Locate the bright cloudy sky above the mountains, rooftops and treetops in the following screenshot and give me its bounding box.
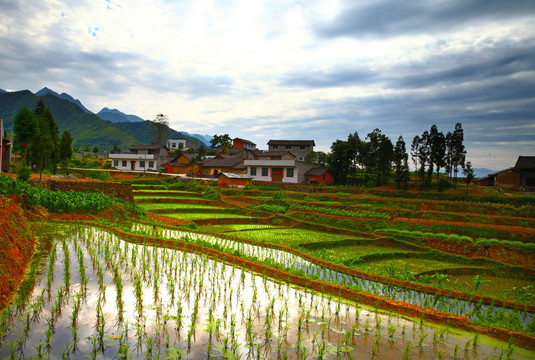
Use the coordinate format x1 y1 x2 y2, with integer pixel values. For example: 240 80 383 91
0 0 535 170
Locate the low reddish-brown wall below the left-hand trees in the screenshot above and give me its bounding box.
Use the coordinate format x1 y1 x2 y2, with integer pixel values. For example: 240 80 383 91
35 180 134 202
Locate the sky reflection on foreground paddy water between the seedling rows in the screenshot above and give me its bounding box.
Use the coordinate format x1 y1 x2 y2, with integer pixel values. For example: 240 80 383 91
0 225 528 359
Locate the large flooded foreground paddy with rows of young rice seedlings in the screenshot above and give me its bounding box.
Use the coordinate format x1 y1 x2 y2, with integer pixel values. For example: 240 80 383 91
0 224 533 359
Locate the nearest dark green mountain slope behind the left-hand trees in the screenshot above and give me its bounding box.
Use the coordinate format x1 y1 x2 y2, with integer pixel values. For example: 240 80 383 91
0 90 142 151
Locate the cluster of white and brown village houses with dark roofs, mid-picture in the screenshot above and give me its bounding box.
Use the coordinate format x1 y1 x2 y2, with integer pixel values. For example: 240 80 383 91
110 138 334 186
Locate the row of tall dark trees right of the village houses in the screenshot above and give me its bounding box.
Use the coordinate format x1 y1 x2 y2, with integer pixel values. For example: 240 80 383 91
324 123 466 189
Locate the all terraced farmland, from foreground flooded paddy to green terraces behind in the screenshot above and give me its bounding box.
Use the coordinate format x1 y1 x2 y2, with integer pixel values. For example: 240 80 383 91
0 176 535 359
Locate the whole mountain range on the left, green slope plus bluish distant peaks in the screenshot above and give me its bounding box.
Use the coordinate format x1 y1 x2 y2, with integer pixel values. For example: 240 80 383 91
0 87 210 151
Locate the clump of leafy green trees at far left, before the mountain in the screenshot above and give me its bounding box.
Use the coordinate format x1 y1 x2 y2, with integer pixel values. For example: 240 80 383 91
13 100 72 179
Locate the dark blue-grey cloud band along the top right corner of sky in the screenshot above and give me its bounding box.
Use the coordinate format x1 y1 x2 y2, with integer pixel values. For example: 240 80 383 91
315 0 535 38
